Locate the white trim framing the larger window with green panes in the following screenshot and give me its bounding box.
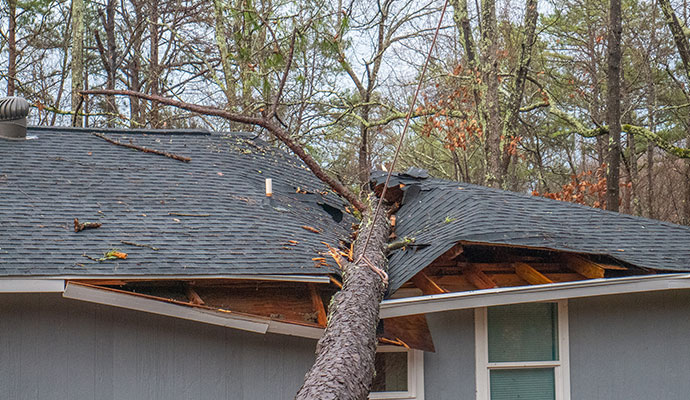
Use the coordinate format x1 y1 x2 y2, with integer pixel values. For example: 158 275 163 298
474 300 570 400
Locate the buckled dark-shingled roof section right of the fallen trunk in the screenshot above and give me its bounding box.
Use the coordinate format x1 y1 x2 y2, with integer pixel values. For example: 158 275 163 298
372 170 690 293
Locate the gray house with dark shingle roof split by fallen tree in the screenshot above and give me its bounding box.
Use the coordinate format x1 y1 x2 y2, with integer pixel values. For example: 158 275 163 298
0 115 690 400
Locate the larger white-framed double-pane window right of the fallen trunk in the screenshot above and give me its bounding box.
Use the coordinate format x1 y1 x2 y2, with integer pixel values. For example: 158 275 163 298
475 301 570 400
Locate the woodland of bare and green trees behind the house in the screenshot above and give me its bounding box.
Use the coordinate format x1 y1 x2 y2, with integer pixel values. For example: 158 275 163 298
0 0 690 225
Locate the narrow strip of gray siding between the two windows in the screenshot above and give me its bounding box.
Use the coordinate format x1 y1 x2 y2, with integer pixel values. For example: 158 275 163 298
424 310 475 400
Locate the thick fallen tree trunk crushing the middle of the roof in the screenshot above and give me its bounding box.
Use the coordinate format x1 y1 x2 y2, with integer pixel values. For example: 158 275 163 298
295 206 390 400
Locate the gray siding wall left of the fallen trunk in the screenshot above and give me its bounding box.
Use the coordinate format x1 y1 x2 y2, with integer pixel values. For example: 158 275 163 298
0 294 316 400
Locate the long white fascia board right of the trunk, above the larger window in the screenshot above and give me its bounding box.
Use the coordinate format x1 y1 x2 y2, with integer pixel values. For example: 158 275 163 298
380 273 690 318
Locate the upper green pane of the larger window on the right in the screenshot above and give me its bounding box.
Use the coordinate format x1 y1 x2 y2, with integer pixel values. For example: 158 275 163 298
487 303 558 362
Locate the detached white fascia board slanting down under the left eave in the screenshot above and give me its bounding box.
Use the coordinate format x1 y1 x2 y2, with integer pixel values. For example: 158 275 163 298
62 283 269 334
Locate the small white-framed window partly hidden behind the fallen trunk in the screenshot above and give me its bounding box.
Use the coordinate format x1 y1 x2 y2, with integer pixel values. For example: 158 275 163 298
369 346 424 400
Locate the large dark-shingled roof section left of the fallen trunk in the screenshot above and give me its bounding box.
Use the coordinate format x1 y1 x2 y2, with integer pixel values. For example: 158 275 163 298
0 127 354 277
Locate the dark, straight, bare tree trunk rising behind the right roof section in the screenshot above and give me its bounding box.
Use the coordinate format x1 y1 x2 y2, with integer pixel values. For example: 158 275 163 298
606 0 623 211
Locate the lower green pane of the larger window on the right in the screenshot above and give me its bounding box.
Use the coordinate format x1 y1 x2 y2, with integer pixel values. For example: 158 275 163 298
489 368 556 400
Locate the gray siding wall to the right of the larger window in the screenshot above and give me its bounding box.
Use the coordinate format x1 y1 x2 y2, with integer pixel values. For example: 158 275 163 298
569 290 690 400
